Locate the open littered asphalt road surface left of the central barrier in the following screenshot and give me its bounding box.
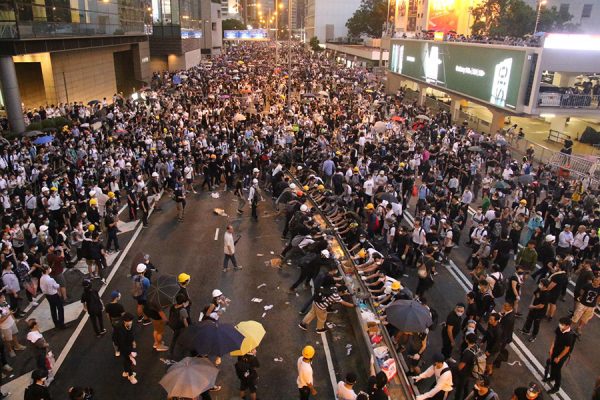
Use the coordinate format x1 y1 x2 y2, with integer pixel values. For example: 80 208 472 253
35 188 368 400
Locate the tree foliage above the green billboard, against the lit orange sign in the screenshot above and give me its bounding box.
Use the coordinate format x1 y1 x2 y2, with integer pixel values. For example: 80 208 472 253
471 0 574 37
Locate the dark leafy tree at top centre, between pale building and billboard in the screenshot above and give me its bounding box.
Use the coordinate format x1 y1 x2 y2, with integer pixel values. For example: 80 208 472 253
346 0 387 37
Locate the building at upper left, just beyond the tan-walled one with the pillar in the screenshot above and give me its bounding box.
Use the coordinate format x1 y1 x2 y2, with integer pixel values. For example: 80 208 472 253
150 0 223 71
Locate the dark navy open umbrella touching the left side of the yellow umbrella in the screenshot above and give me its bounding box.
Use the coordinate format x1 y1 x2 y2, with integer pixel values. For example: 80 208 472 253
178 320 244 357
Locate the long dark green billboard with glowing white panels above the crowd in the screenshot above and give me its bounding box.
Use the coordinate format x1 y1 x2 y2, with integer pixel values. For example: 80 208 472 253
389 40 526 110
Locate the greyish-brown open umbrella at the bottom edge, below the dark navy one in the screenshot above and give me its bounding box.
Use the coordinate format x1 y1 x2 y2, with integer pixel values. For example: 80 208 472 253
159 357 219 399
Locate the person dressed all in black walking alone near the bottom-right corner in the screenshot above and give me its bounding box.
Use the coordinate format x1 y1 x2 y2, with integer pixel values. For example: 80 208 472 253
542 317 576 394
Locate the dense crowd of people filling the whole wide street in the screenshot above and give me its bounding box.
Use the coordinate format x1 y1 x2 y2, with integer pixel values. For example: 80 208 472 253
0 38 600 400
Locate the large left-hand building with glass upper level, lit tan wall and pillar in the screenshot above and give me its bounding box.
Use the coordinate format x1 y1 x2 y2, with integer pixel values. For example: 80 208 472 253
0 0 152 131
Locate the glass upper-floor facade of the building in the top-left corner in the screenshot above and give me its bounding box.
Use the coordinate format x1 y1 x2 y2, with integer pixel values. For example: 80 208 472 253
0 0 152 39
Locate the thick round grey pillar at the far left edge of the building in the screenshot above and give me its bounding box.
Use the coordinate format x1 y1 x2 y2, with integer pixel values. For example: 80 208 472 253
0 56 25 133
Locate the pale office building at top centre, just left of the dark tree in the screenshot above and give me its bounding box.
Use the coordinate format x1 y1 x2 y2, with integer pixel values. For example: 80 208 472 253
304 0 361 43
